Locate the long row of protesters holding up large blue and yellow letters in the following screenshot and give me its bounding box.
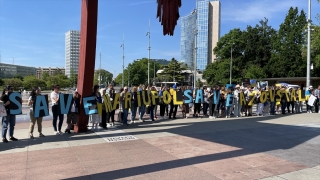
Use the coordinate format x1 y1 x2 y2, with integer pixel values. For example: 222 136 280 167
1 84 320 143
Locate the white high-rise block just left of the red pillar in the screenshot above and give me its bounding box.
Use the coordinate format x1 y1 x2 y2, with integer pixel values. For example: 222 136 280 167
65 30 80 77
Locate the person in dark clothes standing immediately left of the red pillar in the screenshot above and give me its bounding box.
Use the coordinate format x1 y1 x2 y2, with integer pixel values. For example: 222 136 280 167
65 91 80 134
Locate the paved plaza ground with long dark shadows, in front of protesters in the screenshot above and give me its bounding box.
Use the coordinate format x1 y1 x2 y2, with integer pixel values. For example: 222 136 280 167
0 113 320 180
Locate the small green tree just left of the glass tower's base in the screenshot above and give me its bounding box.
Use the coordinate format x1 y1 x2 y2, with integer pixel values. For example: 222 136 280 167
159 58 186 82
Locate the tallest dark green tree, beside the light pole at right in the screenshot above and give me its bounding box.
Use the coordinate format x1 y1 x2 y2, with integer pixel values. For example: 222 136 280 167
268 7 307 77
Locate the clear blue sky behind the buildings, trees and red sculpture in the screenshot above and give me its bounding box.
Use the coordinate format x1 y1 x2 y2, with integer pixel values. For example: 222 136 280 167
0 0 320 75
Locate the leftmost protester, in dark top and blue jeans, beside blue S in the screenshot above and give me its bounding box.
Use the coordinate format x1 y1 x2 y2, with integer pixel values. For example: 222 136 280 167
1 86 18 143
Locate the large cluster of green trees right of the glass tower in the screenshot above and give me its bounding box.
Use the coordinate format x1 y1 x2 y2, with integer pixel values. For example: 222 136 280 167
203 8 310 84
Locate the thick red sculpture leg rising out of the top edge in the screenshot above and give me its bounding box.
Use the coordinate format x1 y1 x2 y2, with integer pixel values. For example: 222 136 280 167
74 0 98 132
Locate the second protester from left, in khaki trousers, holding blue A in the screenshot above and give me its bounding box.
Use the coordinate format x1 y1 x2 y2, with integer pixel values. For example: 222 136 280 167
28 87 44 139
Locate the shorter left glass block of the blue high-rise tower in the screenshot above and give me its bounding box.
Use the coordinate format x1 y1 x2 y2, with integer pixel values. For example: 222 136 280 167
180 10 197 69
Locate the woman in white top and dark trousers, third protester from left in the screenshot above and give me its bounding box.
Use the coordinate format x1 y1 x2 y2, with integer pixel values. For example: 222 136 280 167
50 84 64 135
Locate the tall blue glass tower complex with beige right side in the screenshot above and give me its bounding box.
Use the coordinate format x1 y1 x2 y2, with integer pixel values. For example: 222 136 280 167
181 0 221 70
